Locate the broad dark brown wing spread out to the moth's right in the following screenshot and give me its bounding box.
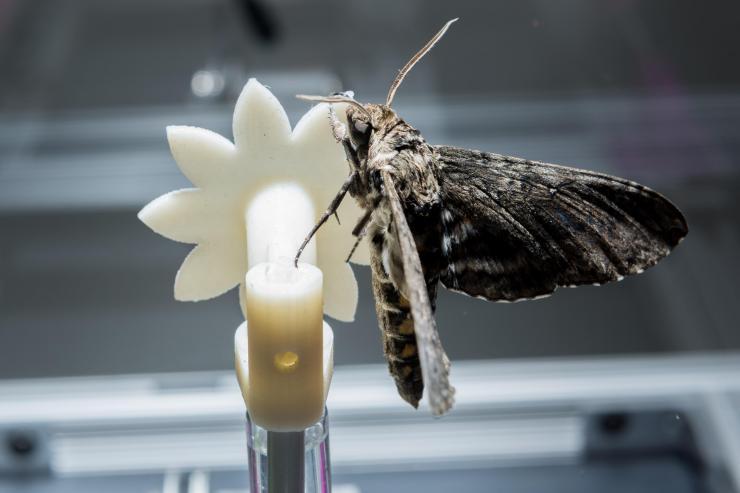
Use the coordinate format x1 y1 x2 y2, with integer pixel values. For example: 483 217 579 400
435 146 688 301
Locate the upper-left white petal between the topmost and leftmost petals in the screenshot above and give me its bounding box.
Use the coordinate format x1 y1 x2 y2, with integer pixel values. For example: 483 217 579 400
167 126 236 188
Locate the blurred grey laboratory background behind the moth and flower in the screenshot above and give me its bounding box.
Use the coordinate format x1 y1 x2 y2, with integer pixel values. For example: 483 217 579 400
0 0 740 493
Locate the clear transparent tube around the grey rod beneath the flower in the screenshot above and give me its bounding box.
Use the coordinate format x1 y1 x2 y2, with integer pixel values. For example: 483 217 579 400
247 410 331 493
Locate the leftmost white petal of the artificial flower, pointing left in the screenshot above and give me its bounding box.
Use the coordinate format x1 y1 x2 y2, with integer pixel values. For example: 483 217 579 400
138 188 213 243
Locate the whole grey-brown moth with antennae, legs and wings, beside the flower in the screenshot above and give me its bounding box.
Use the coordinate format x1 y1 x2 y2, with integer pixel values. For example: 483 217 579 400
296 19 688 415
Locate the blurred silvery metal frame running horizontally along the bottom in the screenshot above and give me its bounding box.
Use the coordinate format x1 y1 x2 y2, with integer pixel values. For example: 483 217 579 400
0 353 740 490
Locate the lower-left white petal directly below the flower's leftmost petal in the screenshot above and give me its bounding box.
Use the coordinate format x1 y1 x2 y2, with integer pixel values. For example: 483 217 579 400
175 241 247 301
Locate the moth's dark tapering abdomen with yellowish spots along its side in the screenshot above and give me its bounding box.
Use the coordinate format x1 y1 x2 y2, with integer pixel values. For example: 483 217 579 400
370 248 424 407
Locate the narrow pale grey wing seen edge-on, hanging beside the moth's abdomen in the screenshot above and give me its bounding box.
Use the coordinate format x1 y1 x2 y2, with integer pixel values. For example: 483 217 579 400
381 171 455 416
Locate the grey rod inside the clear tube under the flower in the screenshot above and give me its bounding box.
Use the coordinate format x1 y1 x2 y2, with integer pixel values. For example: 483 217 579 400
267 431 306 493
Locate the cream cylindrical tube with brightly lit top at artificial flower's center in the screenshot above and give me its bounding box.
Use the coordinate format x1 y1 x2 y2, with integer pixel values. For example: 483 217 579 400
245 182 325 431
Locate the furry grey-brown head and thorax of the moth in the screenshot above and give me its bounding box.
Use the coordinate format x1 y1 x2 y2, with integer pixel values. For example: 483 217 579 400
347 104 439 208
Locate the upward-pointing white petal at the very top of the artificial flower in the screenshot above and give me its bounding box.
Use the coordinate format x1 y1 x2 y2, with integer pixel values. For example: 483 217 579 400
233 79 290 153
